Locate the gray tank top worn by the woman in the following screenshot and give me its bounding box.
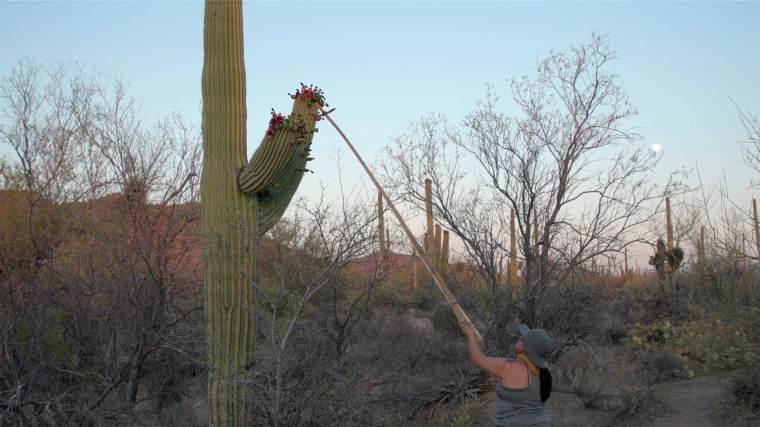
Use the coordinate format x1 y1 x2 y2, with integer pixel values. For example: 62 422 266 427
494 359 552 427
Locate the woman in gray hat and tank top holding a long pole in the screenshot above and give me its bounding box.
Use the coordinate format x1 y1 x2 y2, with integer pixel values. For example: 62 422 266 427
459 323 552 427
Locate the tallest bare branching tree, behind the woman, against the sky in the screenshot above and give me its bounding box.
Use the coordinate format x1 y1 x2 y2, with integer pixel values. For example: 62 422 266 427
382 33 678 334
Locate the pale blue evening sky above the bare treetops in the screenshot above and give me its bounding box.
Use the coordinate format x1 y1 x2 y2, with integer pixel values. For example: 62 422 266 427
0 0 760 264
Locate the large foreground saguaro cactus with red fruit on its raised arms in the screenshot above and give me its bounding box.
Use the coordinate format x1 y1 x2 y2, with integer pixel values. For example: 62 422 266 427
201 0 323 427
